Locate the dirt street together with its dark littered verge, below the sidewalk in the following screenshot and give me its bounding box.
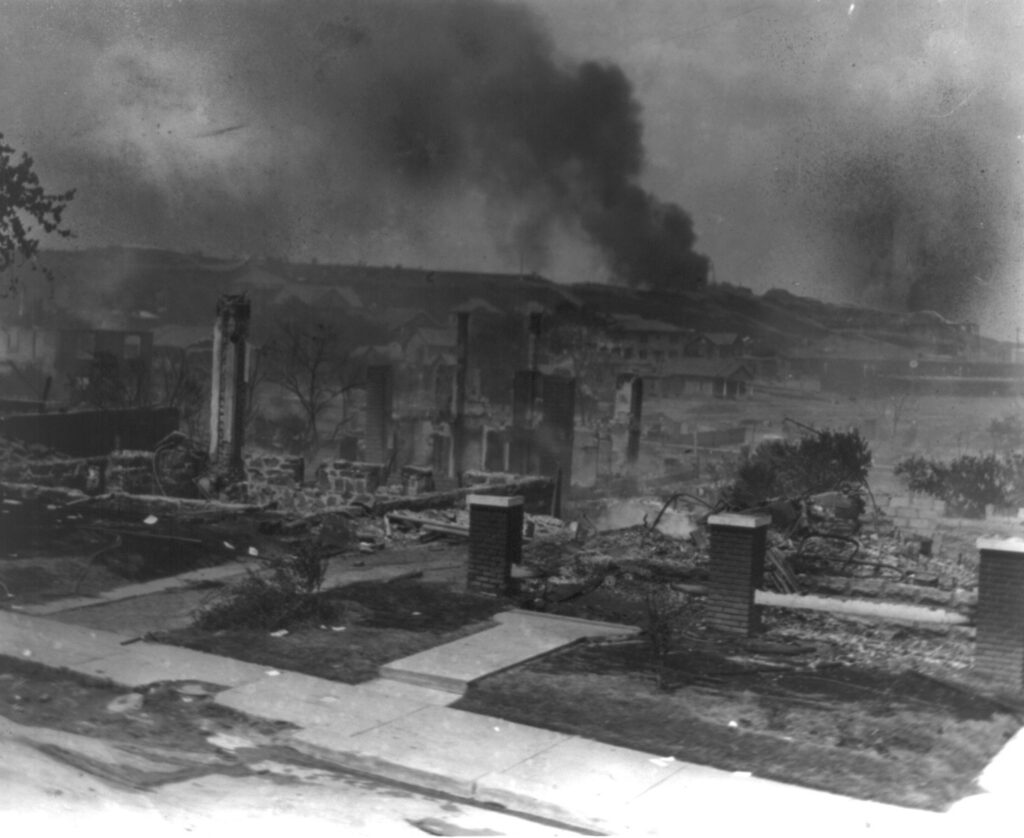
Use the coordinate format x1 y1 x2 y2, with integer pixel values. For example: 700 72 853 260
0 658 566 838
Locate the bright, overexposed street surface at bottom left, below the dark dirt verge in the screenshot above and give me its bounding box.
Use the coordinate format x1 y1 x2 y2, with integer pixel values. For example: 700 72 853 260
0 732 570 838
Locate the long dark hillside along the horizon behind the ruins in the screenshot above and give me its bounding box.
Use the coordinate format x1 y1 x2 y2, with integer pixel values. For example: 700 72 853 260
6 247 991 349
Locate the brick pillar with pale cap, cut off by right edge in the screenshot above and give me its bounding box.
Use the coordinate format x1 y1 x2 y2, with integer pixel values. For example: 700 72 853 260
974 538 1024 689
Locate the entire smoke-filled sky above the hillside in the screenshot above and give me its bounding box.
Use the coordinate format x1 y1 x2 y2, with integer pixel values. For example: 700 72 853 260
0 0 1024 337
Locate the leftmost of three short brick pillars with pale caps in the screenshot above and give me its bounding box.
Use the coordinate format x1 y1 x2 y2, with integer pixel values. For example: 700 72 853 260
466 495 522 596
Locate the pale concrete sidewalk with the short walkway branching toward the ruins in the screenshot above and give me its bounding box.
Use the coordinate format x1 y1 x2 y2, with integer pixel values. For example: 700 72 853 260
0 612 1007 836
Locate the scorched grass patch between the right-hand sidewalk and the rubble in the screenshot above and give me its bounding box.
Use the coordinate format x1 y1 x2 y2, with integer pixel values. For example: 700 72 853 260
455 643 1020 809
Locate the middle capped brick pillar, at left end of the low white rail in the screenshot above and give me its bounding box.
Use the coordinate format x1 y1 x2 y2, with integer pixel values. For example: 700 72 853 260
708 514 771 635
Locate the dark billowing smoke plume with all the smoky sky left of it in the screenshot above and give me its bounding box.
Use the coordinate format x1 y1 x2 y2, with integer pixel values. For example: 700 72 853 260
0 0 708 287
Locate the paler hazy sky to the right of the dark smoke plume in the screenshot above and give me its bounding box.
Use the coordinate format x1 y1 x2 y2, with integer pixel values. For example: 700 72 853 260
548 0 1024 329
